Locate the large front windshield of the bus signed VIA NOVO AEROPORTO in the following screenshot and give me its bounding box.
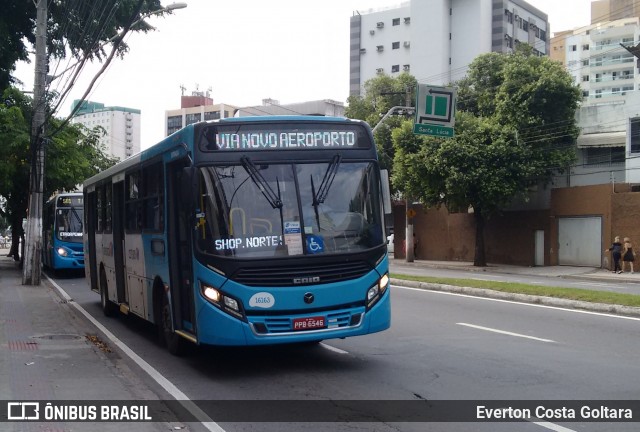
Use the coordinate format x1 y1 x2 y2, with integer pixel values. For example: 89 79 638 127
196 160 383 258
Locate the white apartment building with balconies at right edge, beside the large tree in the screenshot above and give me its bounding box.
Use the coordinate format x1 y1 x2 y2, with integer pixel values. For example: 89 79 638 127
551 17 640 186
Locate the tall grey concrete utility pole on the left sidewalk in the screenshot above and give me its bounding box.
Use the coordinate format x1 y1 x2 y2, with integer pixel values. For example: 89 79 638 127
22 0 47 285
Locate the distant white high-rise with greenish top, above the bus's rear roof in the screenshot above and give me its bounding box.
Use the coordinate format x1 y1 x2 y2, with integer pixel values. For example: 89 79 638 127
72 100 140 160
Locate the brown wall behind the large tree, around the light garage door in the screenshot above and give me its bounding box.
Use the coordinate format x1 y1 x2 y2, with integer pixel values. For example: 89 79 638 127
394 184 640 266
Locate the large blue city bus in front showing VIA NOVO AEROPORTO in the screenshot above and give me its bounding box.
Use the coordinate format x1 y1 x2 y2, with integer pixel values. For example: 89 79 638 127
84 116 391 354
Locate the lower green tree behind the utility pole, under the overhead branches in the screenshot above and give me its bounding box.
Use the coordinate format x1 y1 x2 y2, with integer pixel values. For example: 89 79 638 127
0 88 116 260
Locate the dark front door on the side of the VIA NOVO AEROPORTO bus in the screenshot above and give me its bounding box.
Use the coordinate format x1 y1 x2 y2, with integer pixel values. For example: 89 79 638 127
167 161 196 334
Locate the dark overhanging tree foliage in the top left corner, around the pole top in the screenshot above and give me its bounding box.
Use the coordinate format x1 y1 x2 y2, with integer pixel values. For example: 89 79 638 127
0 0 162 92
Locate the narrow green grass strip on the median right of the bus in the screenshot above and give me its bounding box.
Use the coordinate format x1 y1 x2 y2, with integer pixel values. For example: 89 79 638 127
391 273 640 307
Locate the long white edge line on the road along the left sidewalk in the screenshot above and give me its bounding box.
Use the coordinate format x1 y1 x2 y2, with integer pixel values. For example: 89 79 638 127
44 274 225 432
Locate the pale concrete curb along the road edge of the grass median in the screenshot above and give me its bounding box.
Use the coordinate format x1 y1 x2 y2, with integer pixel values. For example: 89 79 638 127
391 278 640 318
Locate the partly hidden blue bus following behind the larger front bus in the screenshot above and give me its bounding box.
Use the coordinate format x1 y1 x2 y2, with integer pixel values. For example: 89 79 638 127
42 192 84 271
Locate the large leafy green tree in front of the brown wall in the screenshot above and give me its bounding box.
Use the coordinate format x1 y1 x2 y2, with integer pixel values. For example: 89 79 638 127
392 45 581 266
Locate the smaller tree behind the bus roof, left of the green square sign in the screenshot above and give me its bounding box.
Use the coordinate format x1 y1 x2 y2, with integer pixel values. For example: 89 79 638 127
345 72 417 176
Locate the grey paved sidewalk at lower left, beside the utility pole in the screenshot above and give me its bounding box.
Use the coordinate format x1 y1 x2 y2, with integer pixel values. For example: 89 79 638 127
0 253 189 432
